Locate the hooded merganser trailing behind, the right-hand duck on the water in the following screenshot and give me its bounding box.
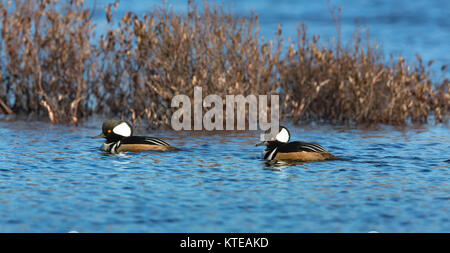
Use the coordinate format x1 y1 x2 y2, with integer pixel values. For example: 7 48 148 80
256 126 340 162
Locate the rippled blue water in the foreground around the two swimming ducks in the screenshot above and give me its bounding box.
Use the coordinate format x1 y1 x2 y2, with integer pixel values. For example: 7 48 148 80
0 120 450 233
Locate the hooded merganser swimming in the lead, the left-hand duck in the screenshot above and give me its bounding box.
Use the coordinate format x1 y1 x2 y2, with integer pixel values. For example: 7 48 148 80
93 119 178 154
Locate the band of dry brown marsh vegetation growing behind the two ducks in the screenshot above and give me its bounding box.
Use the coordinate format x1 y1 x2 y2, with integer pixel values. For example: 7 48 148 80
0 0 450 127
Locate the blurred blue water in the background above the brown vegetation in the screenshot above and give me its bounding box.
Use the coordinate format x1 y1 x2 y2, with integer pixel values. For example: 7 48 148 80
89 0 450 78
